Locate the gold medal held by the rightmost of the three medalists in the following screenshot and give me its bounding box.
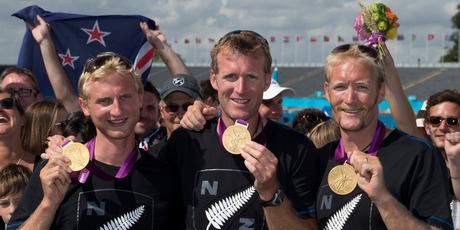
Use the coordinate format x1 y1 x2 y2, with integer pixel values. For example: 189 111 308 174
327 162 358 195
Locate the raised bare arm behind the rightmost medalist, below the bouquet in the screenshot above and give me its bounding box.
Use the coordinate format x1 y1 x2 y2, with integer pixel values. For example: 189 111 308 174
379 38 425 139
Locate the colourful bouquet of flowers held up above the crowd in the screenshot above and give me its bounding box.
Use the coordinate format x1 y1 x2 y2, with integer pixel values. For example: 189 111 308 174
353 3 399 53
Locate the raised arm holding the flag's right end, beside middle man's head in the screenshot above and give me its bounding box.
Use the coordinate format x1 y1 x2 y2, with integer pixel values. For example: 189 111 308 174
140 22 193 76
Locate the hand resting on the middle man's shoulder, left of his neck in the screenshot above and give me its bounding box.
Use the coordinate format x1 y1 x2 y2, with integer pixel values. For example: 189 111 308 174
180 101 218 131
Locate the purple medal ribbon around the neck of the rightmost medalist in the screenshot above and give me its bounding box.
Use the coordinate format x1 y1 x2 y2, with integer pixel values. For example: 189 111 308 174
334 121 386 164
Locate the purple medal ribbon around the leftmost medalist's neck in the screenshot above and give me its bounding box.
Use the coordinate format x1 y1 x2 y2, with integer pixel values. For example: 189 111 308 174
62 137 139 184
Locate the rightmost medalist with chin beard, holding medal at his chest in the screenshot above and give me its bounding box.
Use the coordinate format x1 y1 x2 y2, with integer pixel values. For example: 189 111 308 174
317 40 452 229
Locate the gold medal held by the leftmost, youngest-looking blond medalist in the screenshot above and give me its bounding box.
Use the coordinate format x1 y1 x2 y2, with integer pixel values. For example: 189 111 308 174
62 141 89 172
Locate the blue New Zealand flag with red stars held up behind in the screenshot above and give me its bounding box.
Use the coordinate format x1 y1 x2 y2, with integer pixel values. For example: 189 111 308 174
13 5 155 97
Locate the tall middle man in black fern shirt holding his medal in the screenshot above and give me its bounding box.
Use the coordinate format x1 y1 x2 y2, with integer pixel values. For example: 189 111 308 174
162 31 317 229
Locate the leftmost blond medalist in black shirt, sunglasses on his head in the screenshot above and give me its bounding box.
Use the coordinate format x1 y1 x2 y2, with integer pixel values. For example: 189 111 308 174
8 53 183 229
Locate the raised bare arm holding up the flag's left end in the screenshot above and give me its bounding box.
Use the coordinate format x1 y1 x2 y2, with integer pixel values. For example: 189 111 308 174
26 15 81 112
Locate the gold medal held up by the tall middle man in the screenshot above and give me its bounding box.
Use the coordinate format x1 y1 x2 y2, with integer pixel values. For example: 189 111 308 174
222 121 251 154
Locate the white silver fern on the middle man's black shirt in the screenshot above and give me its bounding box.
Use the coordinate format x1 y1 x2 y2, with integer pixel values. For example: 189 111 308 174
205 186 256 230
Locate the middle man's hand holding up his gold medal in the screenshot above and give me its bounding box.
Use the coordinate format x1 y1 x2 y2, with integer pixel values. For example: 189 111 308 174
241 141 280 201
